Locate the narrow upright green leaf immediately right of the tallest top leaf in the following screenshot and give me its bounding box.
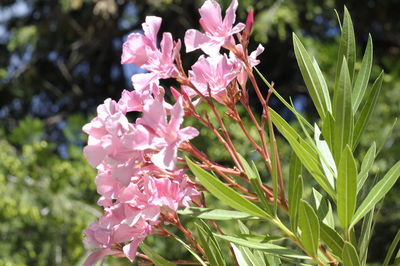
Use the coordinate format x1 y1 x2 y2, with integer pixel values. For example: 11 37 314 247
351 35 373 114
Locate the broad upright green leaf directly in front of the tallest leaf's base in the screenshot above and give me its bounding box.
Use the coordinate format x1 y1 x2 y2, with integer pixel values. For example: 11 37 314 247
333 58 354 163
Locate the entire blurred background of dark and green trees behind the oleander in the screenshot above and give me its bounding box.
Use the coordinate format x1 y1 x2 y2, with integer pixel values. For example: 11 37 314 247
0 0 400 265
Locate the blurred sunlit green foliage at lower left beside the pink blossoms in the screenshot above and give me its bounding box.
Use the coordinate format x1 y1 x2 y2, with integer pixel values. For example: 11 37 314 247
0 118 101 265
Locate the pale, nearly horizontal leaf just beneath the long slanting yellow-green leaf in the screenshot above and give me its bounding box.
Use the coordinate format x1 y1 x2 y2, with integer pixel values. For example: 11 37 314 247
177 207 260 221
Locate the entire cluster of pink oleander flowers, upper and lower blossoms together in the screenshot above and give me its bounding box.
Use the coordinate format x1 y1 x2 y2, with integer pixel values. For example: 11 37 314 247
83 0 263 265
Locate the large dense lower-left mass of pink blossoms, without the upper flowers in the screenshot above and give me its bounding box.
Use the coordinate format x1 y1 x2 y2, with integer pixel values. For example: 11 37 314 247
83 91 198 265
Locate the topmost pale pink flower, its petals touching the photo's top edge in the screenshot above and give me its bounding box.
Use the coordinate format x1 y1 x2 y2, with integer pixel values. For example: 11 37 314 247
185 0 245 55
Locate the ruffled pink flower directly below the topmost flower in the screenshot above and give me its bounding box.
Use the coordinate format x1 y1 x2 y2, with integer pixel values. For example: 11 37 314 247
189 55 239 103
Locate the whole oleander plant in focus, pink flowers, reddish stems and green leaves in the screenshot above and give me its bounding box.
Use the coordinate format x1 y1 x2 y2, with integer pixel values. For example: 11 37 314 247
83 0 400 265
